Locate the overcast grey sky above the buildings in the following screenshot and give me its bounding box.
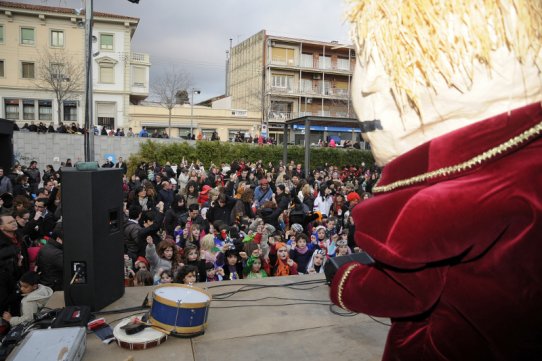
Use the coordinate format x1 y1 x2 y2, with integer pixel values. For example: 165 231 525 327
20 0 351 101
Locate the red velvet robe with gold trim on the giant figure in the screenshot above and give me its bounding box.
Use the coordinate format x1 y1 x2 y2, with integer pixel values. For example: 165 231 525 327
331 103 542 360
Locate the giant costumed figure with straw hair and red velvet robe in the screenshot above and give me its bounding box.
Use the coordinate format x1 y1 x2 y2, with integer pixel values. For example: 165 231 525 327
331 0 542 360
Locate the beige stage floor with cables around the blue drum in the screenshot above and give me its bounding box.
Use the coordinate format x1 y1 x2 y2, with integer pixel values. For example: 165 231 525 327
47 275 389 361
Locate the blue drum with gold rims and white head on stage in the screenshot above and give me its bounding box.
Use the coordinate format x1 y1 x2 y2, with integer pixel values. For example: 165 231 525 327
150 283 215 337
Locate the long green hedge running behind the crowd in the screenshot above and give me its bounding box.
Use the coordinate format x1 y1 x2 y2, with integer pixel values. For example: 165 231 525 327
128 140 374 174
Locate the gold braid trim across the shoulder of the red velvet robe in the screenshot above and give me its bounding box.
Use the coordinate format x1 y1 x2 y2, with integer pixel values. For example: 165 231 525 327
373 122 542 193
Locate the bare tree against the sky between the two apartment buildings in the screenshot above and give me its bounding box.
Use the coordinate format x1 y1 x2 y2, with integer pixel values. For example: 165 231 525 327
151 68 191 138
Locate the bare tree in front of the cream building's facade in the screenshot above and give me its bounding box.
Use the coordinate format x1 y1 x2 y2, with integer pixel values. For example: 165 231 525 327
36 50 85 123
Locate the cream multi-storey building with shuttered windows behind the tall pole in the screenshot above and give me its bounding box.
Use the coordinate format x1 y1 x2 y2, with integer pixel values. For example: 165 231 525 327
0 1 151 128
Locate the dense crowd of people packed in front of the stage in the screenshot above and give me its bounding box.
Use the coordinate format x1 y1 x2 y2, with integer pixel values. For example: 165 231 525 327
0 158 380 328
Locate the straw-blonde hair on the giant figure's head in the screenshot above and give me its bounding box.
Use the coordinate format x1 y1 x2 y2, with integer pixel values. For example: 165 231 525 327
349 0 542 122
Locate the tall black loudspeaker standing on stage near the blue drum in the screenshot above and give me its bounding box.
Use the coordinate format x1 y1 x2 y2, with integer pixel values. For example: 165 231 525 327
61 168 124 311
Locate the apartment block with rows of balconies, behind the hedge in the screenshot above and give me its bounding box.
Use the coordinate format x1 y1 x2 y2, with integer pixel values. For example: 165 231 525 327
228 30 355 141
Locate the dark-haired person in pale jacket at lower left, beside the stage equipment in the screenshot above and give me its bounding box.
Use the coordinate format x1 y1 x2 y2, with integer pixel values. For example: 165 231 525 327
2 271 53 327
